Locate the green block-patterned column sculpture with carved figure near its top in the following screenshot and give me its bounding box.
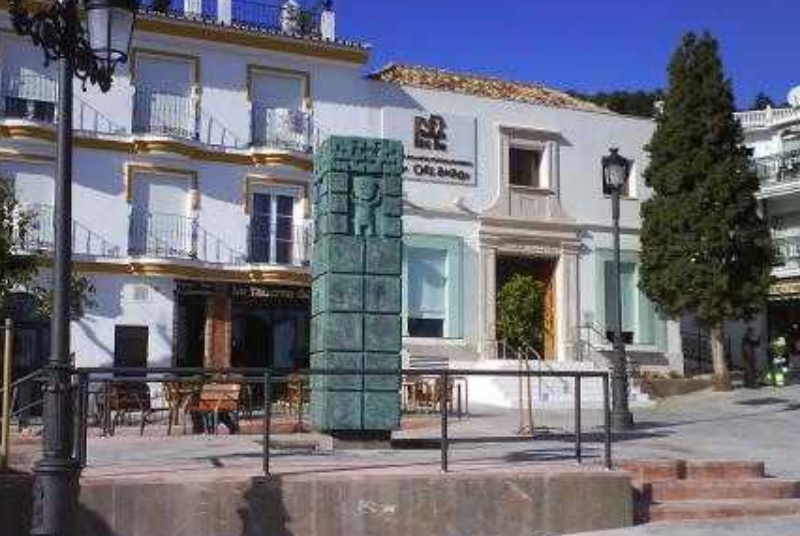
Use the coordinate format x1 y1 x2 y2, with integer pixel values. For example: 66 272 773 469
311 137 403 439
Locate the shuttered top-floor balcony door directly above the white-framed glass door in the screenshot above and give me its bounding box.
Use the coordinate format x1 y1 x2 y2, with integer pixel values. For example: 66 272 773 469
250 70 310 151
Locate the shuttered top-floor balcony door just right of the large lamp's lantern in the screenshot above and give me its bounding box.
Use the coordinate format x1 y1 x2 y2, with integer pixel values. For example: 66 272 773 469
134 54 197 139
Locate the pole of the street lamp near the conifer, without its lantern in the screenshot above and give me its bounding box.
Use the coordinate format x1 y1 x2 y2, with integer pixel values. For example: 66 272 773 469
611 186 634 431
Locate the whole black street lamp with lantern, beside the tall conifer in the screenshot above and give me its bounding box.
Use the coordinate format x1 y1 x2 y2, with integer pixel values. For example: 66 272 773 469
602 149 634 431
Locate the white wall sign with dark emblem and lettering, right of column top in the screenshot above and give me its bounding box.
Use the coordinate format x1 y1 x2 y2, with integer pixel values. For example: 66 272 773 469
382 108 477 185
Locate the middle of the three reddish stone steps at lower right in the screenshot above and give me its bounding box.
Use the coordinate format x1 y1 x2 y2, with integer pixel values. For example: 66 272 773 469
648 478 800 503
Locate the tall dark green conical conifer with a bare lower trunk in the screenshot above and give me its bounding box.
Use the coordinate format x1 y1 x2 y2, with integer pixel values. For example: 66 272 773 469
641 33 772 389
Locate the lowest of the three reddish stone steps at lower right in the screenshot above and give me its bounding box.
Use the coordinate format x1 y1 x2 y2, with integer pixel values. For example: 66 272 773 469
649 499 800 522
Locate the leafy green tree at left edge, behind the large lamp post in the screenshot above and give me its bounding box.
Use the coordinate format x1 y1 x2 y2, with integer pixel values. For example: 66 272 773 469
0 179 95 319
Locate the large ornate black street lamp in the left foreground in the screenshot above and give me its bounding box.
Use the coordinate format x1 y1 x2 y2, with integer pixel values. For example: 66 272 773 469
9 0 138 536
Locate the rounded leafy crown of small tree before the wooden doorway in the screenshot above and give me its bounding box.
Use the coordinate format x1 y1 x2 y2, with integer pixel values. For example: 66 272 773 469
497 274 546 352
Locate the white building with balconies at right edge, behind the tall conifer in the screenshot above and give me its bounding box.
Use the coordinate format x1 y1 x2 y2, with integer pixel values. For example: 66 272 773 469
737 88 800 360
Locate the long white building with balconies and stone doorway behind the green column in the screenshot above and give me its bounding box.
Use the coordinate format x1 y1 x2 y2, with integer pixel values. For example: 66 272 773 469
0 0 682 402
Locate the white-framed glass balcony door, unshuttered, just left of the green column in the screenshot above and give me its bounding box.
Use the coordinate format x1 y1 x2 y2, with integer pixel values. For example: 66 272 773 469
250 192 295 264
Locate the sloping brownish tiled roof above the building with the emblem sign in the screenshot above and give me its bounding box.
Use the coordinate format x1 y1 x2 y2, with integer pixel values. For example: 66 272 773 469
369 63 614 114
